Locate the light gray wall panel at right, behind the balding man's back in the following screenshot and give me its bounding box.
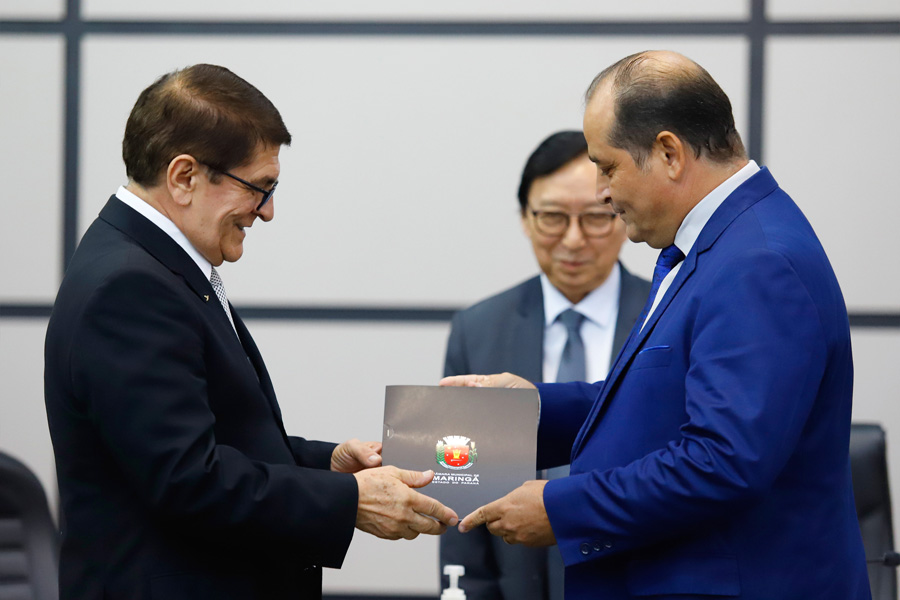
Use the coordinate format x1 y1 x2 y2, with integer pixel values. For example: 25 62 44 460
765 37 900 313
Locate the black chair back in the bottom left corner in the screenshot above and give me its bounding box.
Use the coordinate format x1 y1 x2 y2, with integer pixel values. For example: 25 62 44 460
0 452 59 600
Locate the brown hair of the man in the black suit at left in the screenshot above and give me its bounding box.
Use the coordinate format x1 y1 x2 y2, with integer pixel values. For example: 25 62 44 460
122 64 291 187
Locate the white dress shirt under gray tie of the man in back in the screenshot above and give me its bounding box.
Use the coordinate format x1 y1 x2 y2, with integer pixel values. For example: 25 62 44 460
541 263 622 383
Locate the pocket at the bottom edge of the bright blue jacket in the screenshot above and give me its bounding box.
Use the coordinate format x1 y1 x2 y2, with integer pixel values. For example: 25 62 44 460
625 555 741 597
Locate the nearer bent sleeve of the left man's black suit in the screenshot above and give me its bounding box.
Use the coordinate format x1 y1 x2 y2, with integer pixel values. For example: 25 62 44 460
69 271 357 566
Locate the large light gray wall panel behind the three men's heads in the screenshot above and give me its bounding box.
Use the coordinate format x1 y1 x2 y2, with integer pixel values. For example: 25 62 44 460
79 36 747 306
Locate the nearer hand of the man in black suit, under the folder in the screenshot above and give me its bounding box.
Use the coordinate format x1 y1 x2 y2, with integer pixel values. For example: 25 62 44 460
353 467 459 540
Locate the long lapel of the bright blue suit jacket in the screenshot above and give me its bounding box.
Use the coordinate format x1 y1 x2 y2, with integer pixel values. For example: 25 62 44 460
572 167 778 459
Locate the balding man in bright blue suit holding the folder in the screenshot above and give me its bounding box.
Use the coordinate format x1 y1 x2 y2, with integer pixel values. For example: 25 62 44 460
444 52 870 600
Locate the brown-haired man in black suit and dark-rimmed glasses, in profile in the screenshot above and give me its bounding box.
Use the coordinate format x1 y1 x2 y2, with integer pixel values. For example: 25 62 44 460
45 65 456 600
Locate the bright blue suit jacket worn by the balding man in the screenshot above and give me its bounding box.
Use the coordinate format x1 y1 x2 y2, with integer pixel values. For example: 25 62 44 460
538 169 870 600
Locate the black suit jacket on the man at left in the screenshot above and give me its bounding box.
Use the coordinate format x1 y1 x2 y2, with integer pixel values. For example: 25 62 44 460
44 197 358 600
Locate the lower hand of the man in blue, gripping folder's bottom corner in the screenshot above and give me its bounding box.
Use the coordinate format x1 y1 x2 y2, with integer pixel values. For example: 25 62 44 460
459 481 556 546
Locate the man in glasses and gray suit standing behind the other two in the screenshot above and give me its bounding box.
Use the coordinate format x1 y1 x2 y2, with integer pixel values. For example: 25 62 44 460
440 131 650 600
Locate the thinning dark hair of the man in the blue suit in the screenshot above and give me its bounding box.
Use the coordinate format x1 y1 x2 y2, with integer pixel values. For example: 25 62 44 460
585 52 746 167
